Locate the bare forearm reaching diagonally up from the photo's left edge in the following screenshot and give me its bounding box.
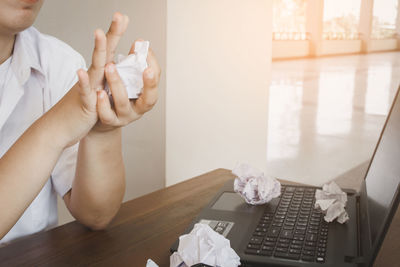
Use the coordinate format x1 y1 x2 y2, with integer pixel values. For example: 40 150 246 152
0 84 97 239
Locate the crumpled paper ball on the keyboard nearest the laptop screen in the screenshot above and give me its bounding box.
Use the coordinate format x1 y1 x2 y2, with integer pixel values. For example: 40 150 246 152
315 182 349 223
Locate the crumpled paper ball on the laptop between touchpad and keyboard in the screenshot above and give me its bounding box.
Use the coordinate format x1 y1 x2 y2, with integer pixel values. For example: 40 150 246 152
232 164 281 205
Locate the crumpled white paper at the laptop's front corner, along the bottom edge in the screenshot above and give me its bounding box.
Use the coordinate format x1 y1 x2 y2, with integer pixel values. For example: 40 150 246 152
170 223 240 267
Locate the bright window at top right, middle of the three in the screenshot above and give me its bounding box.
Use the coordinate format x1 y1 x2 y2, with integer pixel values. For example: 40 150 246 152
323 0 362 40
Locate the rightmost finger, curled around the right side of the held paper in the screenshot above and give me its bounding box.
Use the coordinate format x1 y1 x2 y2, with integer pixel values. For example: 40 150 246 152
132 68 158 114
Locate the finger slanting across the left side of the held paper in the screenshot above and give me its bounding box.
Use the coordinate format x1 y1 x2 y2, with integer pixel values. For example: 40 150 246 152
106 63 131 117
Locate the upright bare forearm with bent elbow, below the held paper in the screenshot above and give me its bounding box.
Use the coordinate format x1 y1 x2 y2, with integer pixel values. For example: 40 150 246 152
64 129 125 229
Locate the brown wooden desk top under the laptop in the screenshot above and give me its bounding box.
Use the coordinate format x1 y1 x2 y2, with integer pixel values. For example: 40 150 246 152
0 169 400 267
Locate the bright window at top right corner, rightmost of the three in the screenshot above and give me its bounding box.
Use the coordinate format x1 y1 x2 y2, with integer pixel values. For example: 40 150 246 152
371 0 398 39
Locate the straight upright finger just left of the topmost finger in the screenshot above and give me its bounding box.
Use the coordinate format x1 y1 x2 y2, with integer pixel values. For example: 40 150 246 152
88 29 107 88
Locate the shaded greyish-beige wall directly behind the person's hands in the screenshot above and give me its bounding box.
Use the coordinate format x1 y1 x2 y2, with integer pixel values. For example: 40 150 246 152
35 0 166 226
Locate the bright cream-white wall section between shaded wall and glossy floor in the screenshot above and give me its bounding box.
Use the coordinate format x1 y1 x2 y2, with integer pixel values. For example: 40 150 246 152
166 0 272 185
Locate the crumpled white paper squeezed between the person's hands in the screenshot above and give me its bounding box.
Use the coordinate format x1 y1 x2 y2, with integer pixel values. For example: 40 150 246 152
104 41 150 99
